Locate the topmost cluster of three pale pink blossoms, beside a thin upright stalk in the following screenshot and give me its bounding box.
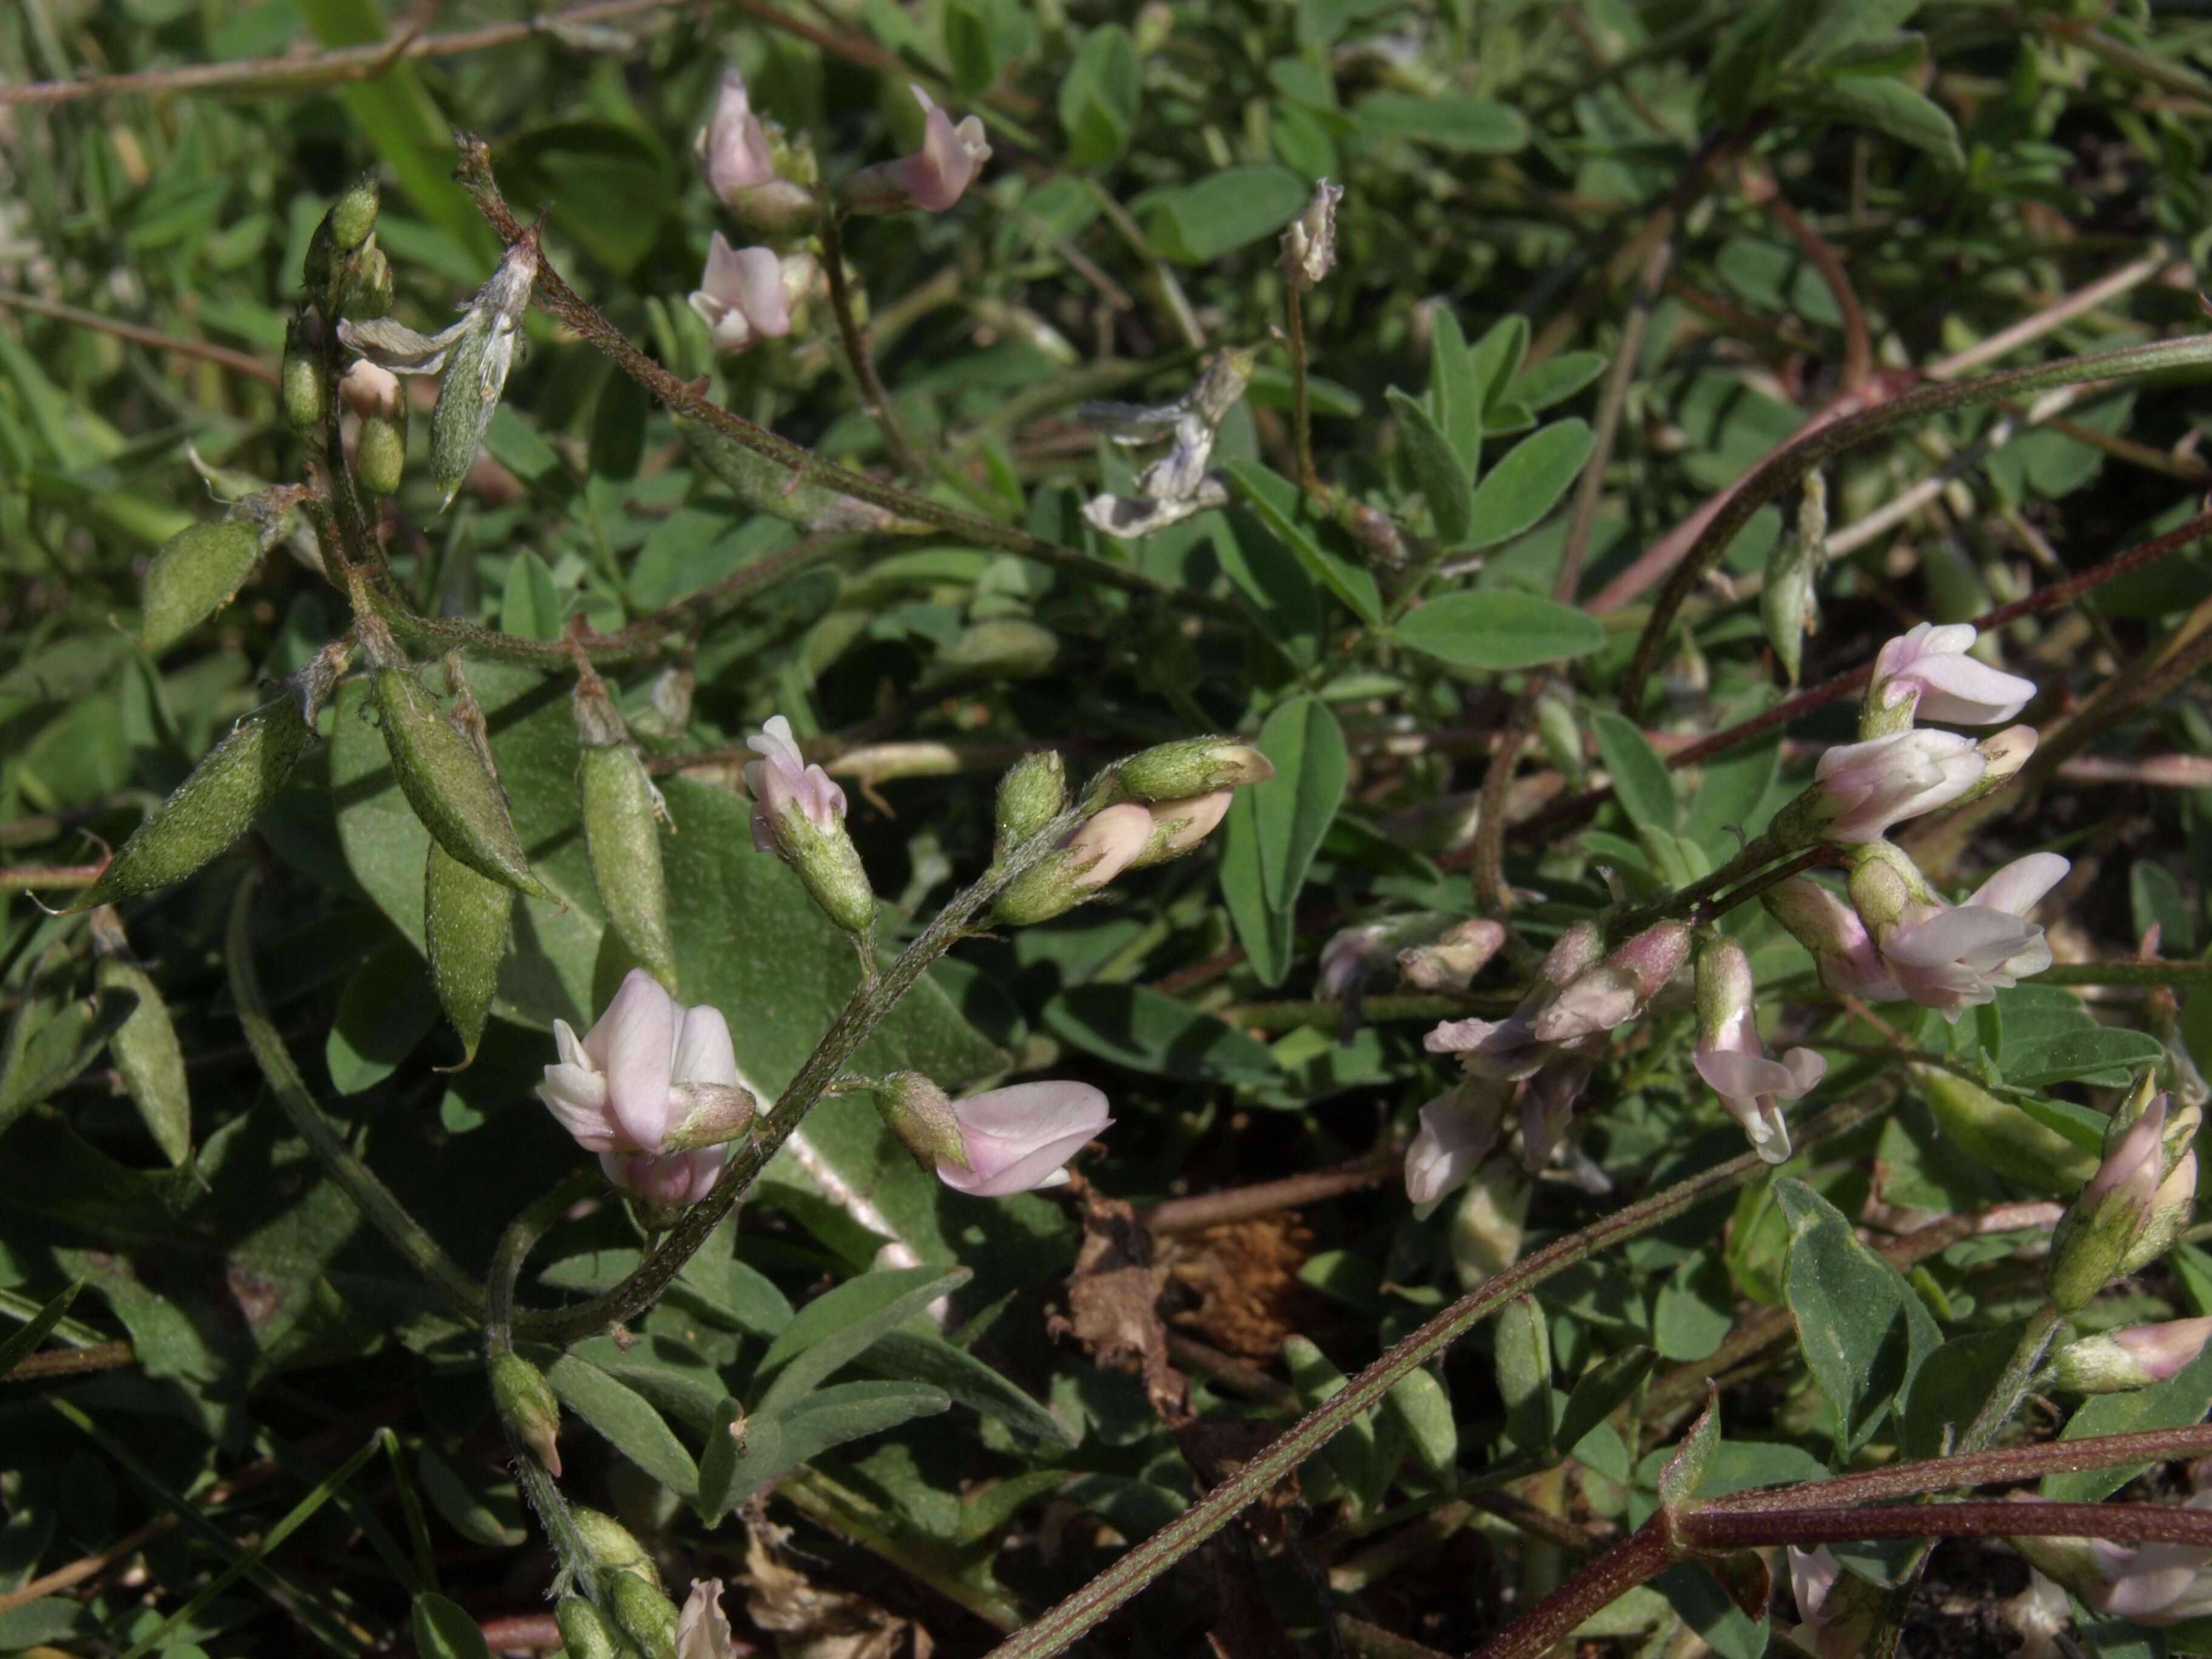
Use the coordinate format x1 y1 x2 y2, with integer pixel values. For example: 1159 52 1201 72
690 69 991 354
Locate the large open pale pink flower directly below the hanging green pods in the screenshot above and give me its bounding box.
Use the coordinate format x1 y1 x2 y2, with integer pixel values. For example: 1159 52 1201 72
537 969 739 1205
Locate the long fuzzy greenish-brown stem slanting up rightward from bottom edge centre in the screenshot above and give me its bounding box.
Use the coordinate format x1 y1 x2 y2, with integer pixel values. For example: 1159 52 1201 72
989 1104 1874 1659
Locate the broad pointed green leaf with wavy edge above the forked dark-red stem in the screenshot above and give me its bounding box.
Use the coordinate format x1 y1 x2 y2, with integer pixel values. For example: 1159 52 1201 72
1774 1181 1942 1460
